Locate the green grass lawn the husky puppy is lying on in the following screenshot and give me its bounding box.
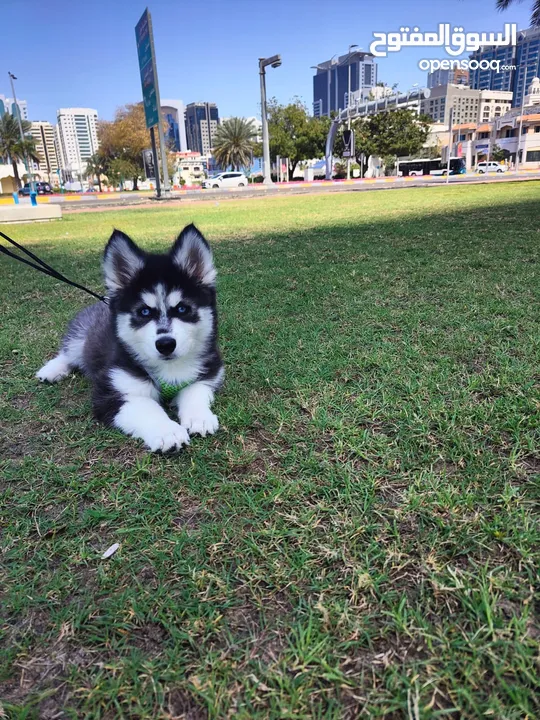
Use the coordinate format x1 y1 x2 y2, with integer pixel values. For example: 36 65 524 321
0 182 540 720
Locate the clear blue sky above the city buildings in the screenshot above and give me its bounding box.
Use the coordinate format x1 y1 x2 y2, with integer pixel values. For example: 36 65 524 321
0 0 532 122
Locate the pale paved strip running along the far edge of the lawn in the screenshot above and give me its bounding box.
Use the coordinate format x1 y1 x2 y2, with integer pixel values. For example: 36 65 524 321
2 170 540 211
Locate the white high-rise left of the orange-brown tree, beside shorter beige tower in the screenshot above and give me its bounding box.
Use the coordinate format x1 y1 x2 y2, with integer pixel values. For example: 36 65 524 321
57 108 99 177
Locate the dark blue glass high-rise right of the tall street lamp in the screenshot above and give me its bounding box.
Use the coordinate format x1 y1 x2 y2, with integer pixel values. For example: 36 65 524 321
313 50 377 117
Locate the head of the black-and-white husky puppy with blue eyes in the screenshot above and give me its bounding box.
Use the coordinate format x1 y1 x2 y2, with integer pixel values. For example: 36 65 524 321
103 225 216 367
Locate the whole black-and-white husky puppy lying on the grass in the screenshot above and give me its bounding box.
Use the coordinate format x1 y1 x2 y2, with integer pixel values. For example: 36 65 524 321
37 225 224 452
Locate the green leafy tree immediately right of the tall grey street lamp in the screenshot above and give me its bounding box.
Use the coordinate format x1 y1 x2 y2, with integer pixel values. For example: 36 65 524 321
255 98 330 177
